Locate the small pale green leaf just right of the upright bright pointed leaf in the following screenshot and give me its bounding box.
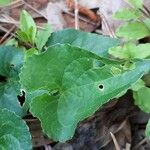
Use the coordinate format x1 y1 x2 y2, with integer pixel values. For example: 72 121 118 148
36 24 52 51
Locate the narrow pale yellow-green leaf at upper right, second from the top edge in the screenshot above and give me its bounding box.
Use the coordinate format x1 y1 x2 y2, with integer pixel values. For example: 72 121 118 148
113 8 142 20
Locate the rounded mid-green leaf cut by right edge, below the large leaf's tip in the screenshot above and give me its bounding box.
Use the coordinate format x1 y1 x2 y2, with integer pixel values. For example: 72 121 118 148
133 87 150 113
